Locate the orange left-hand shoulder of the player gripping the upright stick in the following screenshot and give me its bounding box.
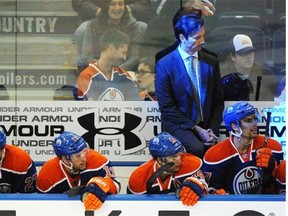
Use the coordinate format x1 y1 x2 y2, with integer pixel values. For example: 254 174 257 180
203 139 237 163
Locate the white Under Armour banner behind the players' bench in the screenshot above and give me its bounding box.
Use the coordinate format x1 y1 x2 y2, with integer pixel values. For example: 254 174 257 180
0 101 286 162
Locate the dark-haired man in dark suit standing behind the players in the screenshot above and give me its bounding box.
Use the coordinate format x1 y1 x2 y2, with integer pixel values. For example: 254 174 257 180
155 10 224 158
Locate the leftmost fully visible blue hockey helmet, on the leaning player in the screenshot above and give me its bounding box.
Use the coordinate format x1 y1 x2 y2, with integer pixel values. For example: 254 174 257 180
52 131 87 157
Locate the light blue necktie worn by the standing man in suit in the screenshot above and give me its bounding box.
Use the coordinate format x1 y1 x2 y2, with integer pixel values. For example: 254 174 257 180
188 56 201 124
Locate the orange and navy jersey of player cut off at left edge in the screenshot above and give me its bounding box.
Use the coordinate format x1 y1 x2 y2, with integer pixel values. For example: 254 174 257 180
0 145 37 193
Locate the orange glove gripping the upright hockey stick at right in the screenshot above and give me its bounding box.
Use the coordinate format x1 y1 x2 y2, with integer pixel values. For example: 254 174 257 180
256 148 277 173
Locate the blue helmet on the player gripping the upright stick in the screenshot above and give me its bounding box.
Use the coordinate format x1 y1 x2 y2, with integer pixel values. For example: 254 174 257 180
223 102 260 131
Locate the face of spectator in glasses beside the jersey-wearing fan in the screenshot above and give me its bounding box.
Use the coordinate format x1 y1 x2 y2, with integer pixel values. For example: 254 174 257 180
136 63 154 90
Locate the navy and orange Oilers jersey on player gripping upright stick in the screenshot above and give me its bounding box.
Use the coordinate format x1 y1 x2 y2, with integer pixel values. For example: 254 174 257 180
202 135 283 194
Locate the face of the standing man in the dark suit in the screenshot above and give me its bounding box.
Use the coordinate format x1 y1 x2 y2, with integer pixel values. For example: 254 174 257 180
180 26 205 55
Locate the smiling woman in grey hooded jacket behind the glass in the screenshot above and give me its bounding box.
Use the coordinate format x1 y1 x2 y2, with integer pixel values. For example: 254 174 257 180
74 0 147 72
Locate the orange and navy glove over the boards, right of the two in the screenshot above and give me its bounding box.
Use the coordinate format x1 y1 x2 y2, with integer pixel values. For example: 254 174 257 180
176 177 208 206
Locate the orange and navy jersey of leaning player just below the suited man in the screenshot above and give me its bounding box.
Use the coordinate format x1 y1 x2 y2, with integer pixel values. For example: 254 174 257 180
127 153 203 194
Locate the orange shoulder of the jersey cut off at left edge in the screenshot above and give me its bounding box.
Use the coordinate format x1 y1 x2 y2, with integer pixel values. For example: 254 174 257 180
5 145 32 172
